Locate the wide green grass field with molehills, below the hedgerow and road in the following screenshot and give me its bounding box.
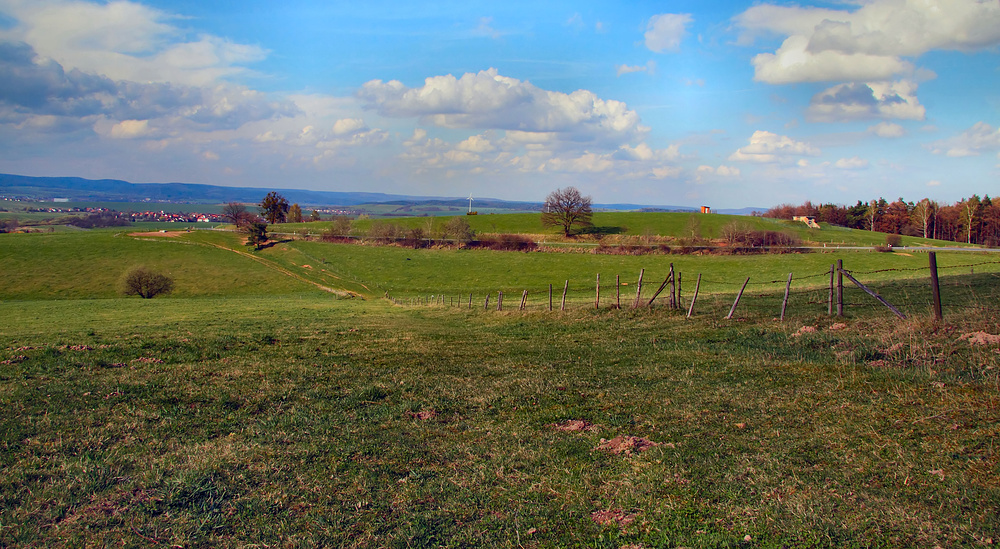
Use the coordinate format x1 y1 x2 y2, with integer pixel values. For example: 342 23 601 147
0 220 1000 548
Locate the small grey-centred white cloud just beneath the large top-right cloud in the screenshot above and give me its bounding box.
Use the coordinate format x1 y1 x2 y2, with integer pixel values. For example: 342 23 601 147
806 80 926 122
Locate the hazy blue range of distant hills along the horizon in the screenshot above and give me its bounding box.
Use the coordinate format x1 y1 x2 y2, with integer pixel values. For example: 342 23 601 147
0 174 766 215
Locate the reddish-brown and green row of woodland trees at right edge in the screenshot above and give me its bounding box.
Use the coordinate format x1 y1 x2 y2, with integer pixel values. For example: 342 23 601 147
761 194 1000 246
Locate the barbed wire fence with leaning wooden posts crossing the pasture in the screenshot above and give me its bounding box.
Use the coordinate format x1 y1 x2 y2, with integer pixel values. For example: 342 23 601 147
387 260 1000 319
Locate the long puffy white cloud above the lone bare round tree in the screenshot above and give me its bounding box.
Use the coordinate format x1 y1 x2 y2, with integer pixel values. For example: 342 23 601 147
357 69 648 144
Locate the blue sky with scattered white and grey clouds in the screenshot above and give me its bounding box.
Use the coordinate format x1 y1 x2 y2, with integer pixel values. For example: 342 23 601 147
0 0 1000 208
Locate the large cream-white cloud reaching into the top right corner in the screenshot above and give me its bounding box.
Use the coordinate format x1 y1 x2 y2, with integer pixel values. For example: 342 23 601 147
735 0 1000 84
